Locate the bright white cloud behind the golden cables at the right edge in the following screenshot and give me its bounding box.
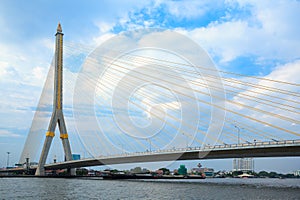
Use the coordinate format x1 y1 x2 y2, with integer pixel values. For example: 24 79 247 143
227 60 300 139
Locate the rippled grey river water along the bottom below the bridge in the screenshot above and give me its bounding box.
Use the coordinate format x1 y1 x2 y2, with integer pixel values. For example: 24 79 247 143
0 178 300 200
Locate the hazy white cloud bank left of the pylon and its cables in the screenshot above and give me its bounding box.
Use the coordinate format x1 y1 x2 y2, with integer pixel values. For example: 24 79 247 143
0 39 54 134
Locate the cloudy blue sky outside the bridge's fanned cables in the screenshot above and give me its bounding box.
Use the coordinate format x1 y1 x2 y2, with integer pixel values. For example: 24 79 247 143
0 0 300 173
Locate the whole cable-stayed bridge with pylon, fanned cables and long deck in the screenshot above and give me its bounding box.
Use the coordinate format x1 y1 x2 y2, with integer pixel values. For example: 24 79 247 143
20 24 300 173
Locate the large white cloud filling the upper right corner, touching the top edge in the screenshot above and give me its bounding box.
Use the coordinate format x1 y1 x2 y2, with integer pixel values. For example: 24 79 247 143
170 1 300 62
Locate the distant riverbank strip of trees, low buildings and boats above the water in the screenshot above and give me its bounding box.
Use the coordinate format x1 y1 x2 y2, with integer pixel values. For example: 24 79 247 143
0 165 300 179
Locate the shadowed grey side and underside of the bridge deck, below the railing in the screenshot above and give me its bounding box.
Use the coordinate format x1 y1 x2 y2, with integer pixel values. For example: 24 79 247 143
45 145 300 169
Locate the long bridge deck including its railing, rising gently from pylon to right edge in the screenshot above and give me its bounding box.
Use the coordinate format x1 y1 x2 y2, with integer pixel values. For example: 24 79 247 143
45 140 300 169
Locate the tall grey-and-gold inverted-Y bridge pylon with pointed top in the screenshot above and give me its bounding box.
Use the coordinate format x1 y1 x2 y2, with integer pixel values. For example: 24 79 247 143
35 23 75 176
